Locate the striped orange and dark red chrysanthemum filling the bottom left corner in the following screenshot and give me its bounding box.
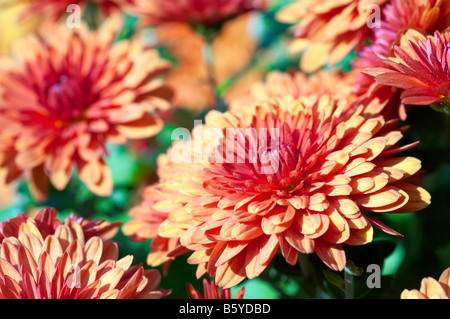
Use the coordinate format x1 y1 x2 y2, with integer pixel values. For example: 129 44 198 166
0 209 169 299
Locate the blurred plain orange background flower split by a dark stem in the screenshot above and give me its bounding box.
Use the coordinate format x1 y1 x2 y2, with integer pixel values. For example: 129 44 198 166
152 14 258 110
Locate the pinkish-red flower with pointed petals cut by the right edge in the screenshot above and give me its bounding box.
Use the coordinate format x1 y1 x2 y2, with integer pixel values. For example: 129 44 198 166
366 30 450 112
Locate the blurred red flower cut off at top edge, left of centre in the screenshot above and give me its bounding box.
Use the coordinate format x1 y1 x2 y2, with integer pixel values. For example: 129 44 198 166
119 0 265 26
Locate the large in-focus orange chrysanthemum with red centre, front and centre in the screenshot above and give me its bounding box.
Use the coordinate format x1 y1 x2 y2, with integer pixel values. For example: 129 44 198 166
126 96 430 288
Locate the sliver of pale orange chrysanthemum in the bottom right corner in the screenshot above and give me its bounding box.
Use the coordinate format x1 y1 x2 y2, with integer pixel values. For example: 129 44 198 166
400 268 450 299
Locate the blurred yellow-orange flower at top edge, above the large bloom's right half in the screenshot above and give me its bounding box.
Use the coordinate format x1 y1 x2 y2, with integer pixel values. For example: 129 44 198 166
277 0 387 72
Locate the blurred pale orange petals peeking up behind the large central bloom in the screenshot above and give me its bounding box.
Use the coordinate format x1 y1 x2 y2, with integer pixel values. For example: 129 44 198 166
230 70 353 109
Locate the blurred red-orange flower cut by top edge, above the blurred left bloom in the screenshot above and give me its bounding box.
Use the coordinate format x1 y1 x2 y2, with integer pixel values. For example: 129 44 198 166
21 0 120 21
